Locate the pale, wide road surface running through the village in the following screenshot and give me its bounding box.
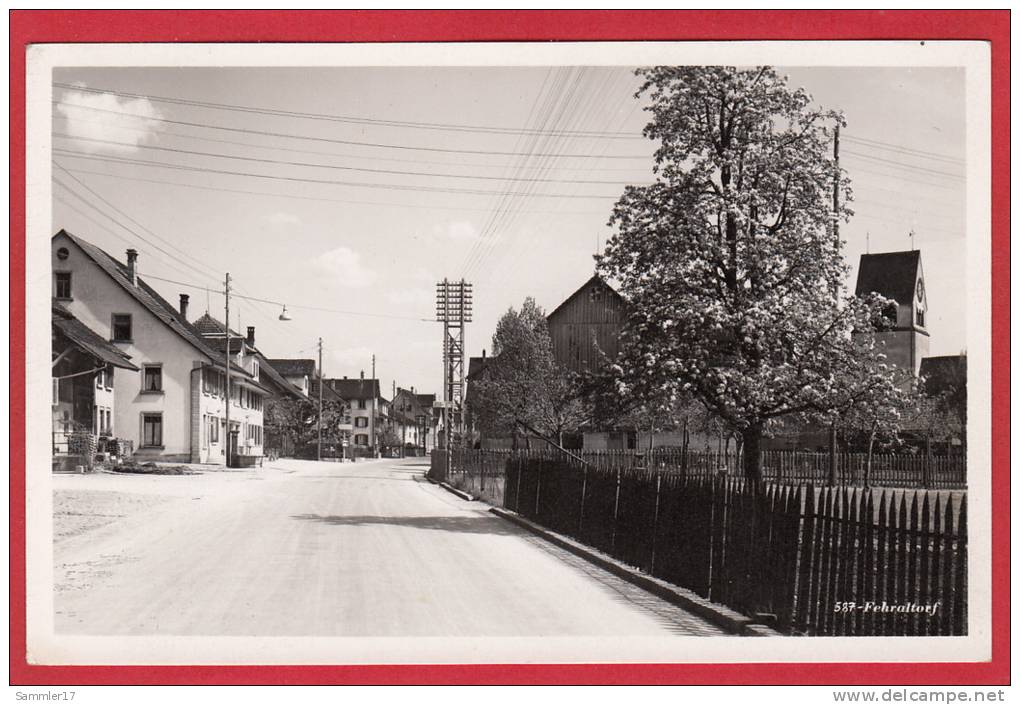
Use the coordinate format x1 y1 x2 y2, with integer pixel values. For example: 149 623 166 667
54 460 720 637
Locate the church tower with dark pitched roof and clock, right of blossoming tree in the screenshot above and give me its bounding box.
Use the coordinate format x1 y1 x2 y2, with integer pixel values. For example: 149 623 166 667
857 250 929 377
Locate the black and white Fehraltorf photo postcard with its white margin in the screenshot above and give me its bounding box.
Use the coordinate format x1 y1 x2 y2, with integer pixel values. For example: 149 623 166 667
28 42 990 663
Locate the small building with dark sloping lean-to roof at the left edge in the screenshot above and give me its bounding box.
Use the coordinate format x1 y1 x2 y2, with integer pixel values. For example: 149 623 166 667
51 299 139 463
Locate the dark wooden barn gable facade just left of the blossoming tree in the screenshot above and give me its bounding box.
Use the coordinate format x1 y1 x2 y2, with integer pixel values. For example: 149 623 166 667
547 274 626 372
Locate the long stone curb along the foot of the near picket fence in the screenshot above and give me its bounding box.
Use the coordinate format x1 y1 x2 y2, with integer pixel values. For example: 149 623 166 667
489 507 782 637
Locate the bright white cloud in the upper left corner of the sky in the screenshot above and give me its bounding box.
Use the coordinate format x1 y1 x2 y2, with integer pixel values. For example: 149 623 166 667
57 86 162 154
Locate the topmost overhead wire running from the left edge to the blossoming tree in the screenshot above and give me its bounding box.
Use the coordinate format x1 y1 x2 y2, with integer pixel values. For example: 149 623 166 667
53 82 642 140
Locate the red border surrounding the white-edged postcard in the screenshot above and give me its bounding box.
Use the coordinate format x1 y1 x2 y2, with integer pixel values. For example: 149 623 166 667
9 10 1010 685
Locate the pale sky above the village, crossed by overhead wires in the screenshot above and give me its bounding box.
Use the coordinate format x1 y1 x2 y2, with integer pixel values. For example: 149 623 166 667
52 66 966 396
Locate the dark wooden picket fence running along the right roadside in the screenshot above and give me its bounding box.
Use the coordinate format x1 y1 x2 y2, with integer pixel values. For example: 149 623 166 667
430 451 967 636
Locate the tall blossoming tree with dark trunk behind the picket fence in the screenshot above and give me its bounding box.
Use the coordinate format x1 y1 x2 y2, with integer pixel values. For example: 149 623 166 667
599 66 909 481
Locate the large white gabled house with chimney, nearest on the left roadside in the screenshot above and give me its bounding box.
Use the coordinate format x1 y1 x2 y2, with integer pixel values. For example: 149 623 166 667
51 231 269 464
